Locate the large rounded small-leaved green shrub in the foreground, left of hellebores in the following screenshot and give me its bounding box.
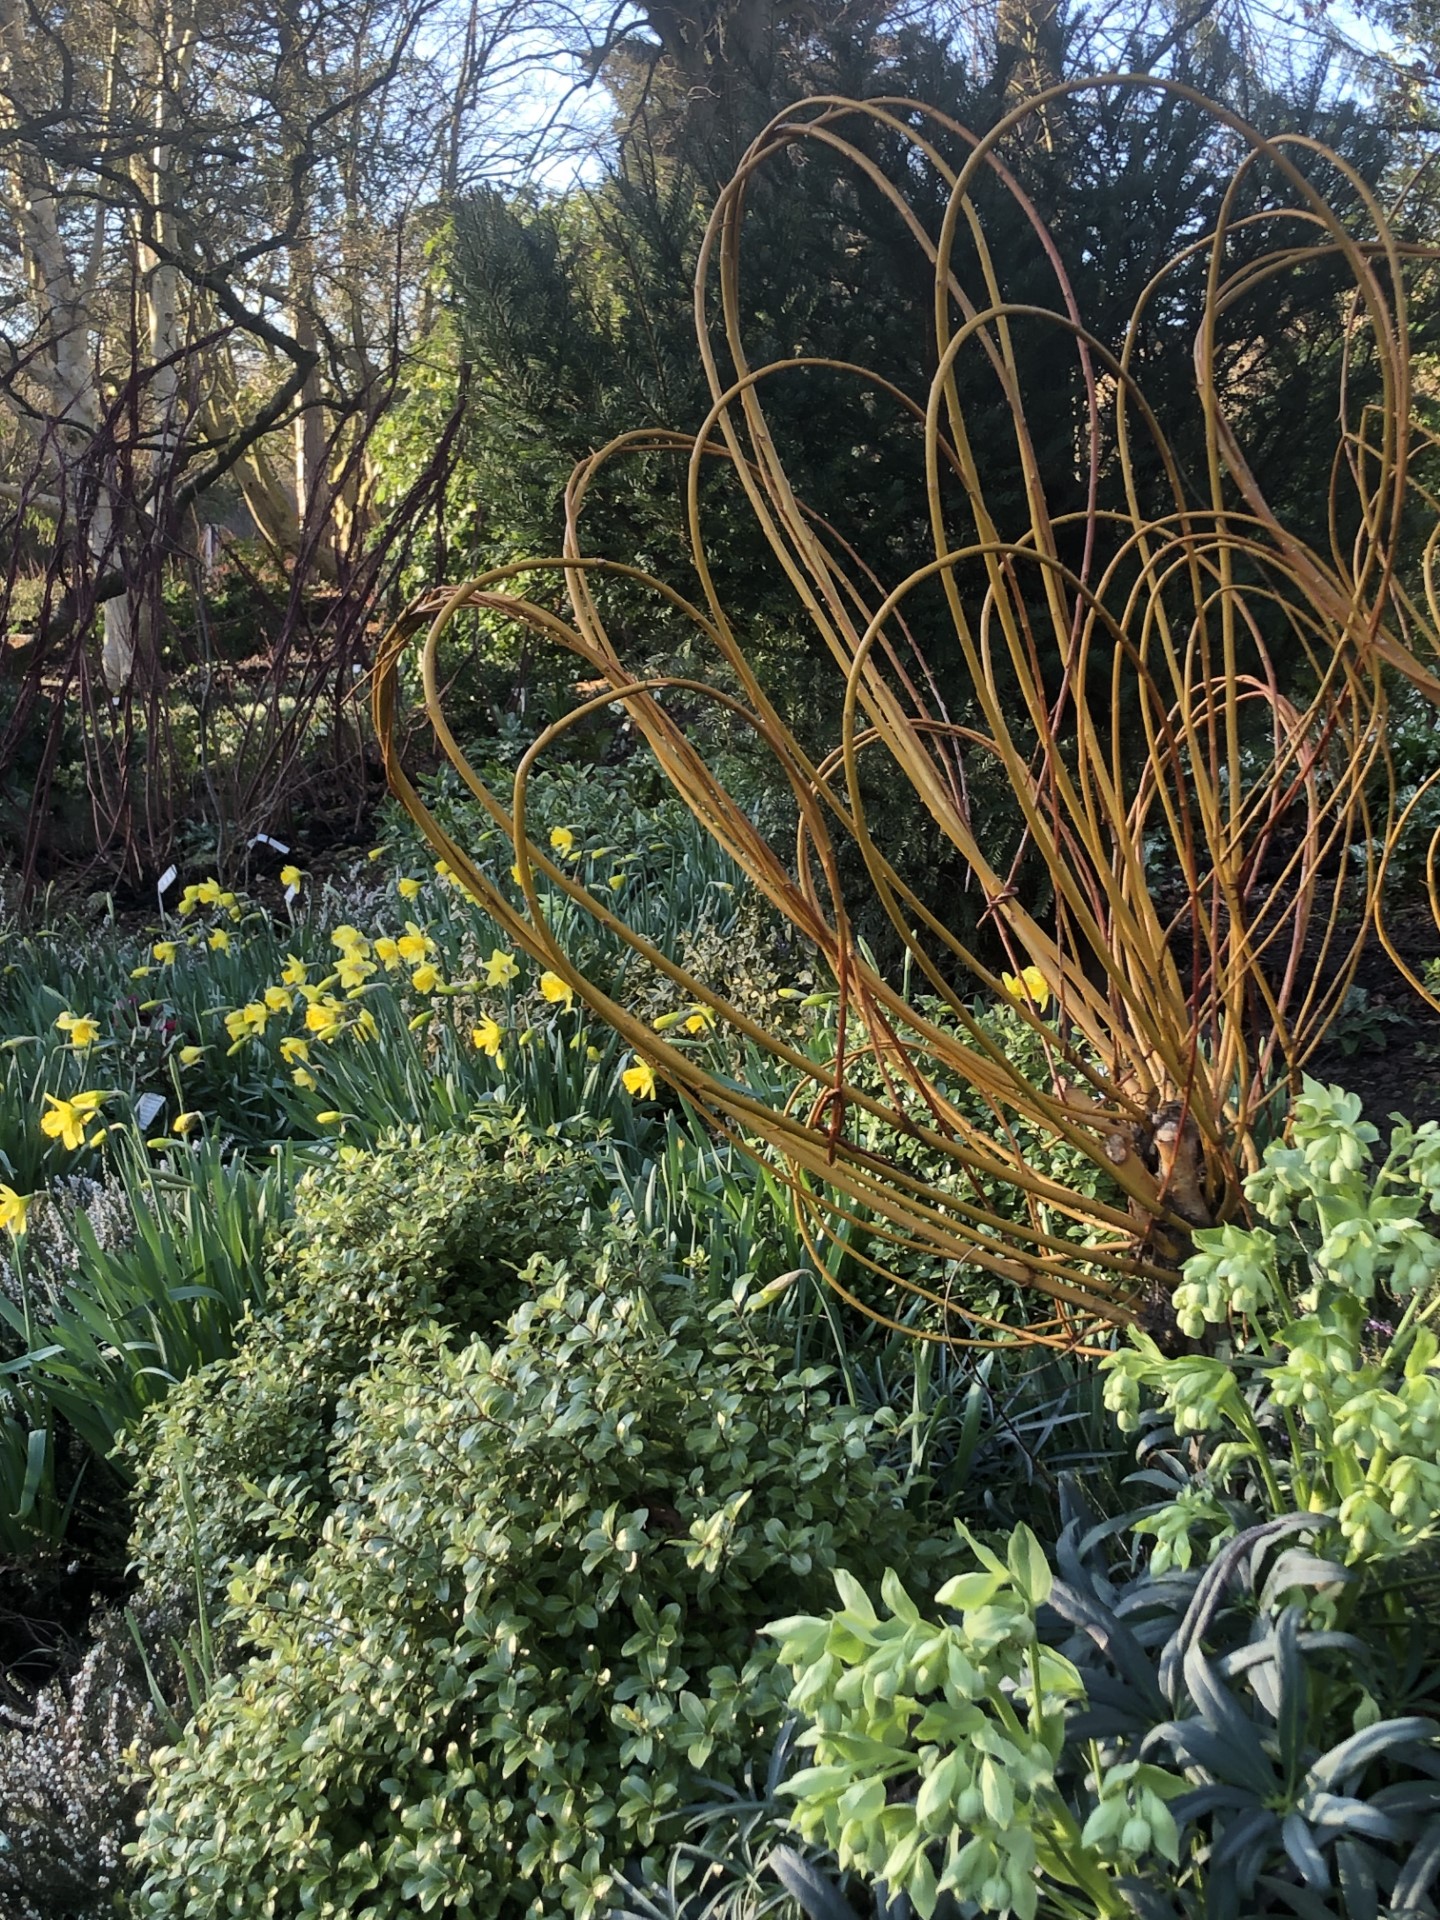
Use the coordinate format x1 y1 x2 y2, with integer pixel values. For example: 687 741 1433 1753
134 1229 924 1920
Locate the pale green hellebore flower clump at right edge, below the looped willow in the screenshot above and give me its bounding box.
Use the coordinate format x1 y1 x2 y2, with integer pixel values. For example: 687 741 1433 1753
1102 1081 1440 1565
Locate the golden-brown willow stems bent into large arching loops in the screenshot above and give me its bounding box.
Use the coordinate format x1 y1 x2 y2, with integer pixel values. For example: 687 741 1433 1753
374 75 1440 1344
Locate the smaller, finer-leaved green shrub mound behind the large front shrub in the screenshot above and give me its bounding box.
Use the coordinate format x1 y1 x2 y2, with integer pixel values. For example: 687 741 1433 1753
125 1112 593 1603
